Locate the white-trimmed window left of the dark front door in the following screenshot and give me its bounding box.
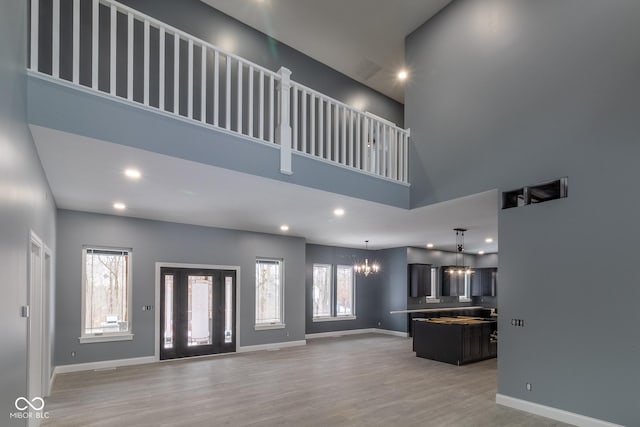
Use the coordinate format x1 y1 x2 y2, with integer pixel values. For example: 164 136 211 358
80 247 133 343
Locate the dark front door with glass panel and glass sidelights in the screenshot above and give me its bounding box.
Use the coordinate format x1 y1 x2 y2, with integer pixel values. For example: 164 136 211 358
160 268 236 360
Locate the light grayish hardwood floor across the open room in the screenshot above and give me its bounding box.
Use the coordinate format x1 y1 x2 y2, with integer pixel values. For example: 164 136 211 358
43 334 565 427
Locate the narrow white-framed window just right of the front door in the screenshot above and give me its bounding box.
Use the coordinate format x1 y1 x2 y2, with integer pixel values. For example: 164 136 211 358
255 259 284 329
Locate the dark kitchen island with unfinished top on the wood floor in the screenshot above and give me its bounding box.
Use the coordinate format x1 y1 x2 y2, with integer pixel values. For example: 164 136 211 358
413 316 497 365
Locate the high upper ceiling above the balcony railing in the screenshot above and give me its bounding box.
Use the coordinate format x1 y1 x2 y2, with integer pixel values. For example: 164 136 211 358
202 0 451 103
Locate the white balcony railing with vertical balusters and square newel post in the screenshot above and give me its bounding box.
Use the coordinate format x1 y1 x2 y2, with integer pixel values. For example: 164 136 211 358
29 0 409 183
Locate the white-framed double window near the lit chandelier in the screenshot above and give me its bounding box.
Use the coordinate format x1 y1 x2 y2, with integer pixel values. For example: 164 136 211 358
313 264 355 322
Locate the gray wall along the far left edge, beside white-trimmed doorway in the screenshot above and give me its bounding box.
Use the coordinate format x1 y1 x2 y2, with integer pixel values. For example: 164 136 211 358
0 0 56 426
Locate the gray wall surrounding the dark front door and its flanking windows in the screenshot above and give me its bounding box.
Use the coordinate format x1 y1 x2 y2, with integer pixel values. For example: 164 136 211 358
55 210 305 365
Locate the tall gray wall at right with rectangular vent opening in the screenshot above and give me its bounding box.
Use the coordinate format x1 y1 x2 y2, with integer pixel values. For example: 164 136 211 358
405 0 640 425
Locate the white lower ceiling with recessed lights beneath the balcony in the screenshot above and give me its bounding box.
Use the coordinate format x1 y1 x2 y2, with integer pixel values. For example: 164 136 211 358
31 126 498 253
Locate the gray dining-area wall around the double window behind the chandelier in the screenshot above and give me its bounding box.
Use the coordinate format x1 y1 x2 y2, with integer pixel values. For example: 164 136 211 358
306 244 386 334
